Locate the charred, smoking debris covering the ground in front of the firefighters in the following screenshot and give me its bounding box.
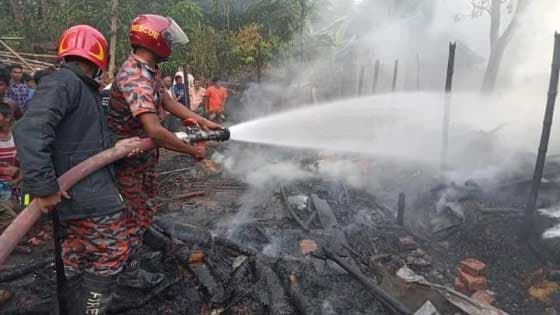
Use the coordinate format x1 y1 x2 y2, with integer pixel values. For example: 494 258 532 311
5 149 560 314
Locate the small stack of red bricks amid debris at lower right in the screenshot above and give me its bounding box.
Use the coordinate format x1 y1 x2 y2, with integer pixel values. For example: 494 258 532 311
453 258 494 304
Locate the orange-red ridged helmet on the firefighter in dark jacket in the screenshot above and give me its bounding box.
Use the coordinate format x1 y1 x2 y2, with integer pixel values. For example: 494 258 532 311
57 25 109 71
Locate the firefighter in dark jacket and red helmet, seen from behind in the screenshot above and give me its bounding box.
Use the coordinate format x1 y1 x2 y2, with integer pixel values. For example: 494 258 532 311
14 25 142 314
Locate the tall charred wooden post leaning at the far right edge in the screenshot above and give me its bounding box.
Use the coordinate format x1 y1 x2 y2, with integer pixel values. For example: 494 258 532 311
523 33 560 240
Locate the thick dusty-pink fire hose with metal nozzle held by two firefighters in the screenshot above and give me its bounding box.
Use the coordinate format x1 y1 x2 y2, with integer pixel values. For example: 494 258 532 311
0 127 230 270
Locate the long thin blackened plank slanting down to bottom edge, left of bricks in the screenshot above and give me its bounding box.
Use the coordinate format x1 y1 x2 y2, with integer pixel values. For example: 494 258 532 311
323 247 413 315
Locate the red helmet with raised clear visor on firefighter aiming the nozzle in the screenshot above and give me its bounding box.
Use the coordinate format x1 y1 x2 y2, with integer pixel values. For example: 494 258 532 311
129 14 189 61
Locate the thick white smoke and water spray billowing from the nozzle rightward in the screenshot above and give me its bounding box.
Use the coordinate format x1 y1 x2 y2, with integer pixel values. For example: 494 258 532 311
224 0 560 242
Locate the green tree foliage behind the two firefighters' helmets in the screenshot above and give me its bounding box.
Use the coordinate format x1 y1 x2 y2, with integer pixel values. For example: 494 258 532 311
0 0 318 80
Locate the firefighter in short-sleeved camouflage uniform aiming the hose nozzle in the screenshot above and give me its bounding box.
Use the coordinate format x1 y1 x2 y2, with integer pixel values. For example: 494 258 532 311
108 14 222 288
